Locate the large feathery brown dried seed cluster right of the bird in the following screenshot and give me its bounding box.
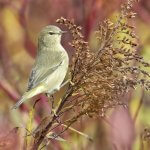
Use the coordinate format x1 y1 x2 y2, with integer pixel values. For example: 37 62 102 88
57 0 150 117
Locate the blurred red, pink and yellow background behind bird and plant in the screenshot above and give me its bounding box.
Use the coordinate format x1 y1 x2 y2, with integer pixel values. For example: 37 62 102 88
0 0 150 150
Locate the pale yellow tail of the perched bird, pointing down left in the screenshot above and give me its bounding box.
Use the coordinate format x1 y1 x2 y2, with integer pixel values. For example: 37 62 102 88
12 86 43 109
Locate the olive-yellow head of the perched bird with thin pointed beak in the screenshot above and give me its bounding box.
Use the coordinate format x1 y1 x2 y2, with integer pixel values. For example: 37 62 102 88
38 25 65 46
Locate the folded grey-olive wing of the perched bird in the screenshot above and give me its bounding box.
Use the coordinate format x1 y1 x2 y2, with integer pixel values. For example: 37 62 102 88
27 52 63 91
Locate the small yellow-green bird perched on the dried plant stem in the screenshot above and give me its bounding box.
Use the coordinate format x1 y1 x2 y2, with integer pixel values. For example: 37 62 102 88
12 25 69 109
